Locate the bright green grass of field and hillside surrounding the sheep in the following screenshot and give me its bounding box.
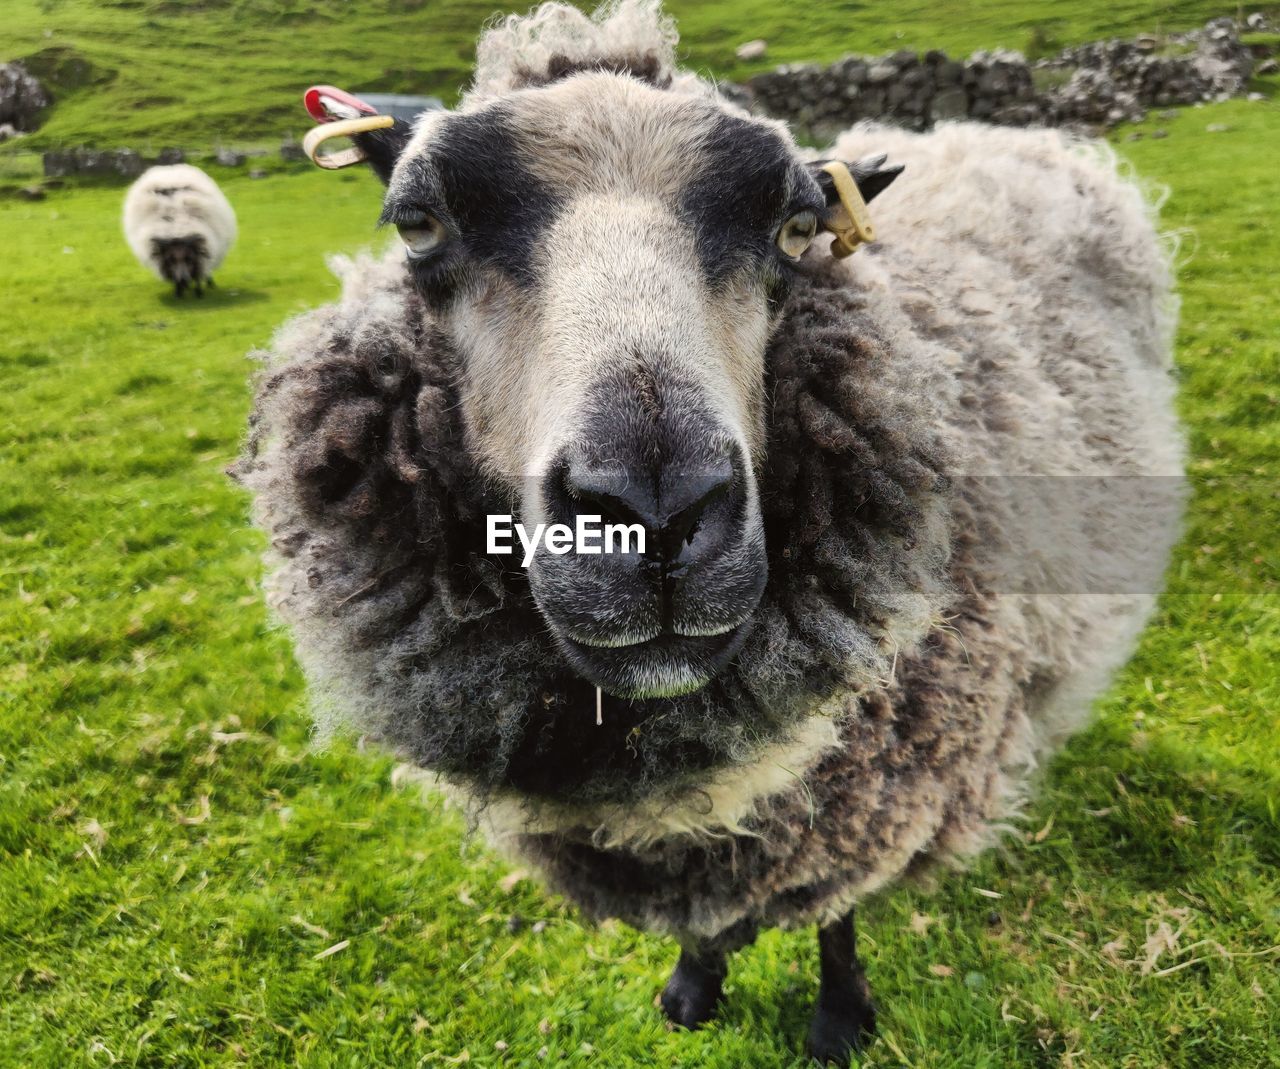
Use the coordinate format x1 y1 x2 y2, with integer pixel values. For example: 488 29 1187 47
0 0 1280 1069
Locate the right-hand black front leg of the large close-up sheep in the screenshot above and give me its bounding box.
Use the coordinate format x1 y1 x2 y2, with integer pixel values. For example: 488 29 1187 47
809 910 876 1065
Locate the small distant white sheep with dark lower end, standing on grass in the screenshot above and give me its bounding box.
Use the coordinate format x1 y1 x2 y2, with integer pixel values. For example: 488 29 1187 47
124 164 236 297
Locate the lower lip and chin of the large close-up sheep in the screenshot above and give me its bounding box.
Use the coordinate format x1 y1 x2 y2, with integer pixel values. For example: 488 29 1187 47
552 618 753 700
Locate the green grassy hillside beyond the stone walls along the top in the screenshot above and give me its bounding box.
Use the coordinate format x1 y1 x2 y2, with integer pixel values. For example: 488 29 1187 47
0 0 1259 151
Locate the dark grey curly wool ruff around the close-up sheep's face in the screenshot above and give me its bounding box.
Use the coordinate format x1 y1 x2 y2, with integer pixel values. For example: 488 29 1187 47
234 257 948 803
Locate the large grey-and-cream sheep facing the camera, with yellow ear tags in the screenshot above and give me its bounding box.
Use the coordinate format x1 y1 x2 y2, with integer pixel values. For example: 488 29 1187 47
234 0 1183 1061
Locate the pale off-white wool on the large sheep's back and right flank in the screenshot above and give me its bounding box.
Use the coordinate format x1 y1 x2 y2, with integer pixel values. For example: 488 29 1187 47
822 123 1185 760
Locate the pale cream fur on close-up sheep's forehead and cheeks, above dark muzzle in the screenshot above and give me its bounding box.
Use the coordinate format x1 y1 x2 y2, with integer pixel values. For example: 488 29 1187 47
417 74 794 478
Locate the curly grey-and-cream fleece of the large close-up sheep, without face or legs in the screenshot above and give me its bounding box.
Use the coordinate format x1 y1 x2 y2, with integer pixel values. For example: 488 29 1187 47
238 4 1181 938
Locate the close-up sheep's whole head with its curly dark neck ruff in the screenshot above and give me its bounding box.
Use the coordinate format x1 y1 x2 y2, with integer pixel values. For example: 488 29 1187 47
244 8 951 808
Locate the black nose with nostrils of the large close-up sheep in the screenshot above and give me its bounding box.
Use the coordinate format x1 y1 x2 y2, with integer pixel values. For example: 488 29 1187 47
564 456 741 565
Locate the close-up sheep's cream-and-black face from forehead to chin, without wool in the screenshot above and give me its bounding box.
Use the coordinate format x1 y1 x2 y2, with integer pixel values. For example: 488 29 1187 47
384 73 826 698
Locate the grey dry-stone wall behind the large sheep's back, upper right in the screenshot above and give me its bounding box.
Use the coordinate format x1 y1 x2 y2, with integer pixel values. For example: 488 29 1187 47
740 19 1253 141
